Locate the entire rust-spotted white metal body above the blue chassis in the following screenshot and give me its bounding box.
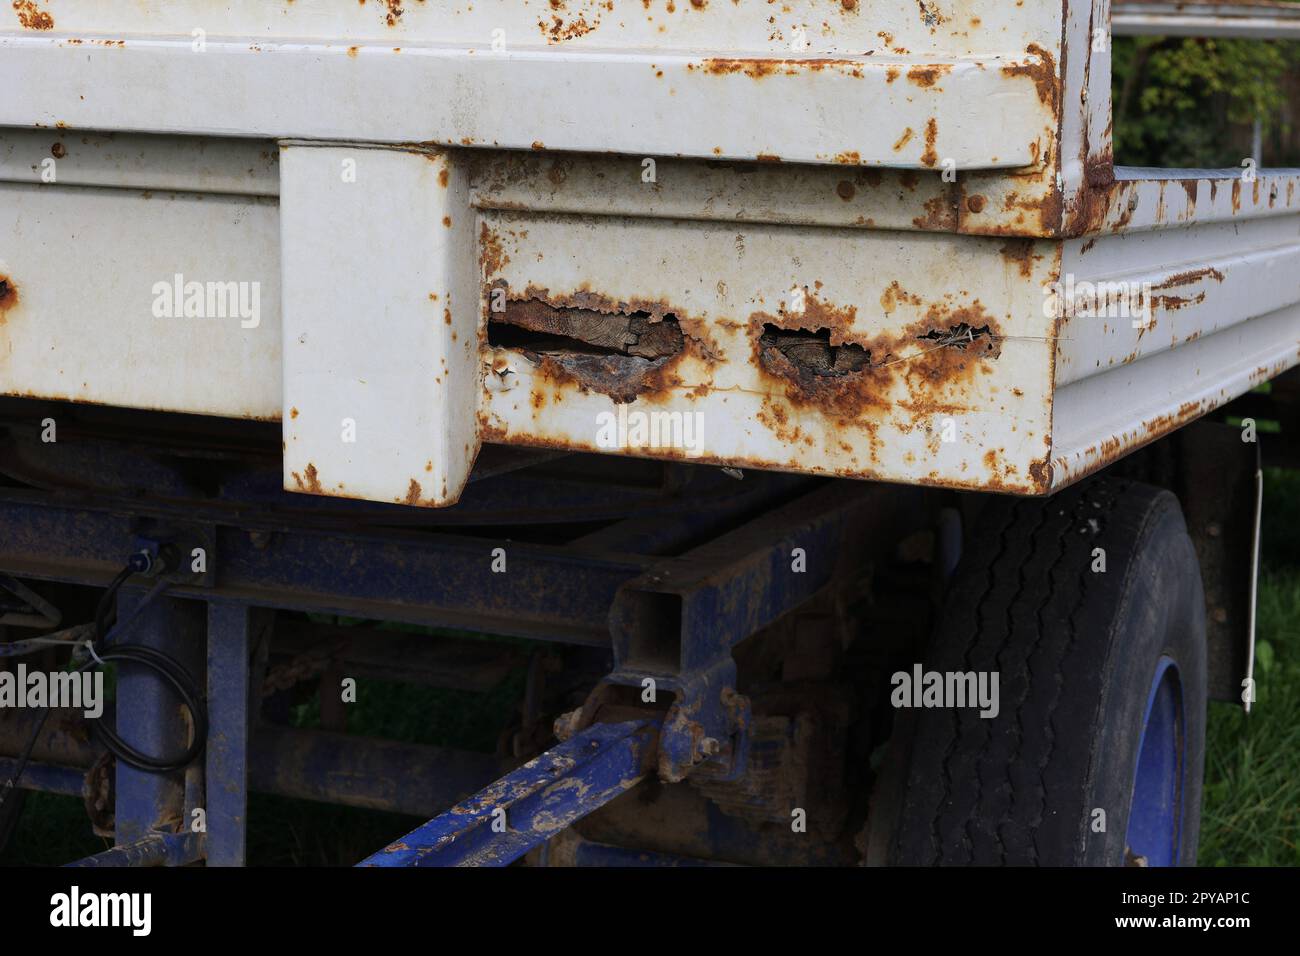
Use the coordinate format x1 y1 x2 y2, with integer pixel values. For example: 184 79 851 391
0 0 1300 506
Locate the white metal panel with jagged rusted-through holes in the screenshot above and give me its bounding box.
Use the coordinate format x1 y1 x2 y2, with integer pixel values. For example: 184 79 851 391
480 212 1056 493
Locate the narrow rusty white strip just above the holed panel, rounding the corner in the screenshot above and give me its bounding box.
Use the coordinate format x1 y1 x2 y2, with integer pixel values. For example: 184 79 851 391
471 152 1300 238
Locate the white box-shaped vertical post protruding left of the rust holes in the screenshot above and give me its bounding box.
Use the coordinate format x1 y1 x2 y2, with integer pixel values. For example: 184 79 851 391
280 144 478 506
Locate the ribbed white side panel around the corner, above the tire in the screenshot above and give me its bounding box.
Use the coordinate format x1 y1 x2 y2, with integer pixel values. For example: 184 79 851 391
1052 208 1300 488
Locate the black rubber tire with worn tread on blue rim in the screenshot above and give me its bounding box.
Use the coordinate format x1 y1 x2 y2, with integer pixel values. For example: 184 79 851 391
878 479 1206 866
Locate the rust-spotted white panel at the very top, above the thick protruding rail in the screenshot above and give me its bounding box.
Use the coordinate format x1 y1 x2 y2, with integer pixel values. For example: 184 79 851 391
0 0 1061 55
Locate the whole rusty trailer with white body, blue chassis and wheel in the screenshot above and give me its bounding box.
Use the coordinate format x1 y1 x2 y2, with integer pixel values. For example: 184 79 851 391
0 0 1300 865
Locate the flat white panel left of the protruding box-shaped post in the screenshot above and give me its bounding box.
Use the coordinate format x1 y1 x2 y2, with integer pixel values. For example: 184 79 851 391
0 181 281 419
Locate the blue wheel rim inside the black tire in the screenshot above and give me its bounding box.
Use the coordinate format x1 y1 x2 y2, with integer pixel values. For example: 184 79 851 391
1126 657 1186 866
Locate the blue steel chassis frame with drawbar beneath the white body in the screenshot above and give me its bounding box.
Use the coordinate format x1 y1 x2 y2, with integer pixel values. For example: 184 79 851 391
0 411 915 866
